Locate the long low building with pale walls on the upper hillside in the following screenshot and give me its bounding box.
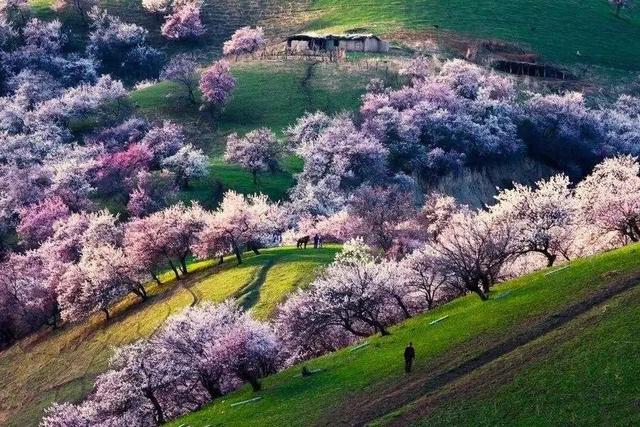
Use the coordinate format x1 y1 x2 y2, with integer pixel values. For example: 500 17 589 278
287 33 389 52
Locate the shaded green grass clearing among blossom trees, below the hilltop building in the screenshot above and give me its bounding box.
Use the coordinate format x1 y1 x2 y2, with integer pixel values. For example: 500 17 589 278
131 61 396 206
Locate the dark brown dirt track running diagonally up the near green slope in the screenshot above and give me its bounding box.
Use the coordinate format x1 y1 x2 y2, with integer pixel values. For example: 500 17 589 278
319 273 640 426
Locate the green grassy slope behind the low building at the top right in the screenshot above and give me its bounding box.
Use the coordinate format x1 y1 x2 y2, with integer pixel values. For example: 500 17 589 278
307 0 640 71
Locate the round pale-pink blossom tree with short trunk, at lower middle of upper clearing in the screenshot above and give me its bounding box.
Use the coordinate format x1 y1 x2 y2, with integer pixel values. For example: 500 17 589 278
224 128 280 184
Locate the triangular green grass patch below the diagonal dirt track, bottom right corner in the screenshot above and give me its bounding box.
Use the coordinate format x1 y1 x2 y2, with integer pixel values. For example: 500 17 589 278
402 288 640 426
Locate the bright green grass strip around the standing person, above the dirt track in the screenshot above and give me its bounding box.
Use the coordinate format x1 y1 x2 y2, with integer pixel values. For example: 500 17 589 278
172 245 640 426
